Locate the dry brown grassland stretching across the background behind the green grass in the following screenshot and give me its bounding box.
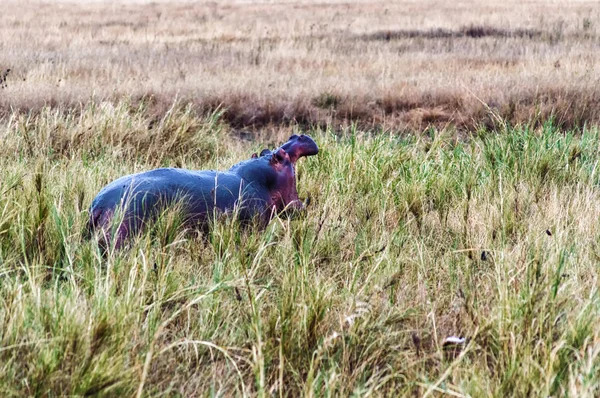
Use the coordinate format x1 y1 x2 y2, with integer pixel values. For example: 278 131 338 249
0 0 600 130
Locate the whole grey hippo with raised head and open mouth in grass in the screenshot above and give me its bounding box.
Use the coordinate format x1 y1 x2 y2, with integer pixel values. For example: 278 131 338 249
88 135 319 249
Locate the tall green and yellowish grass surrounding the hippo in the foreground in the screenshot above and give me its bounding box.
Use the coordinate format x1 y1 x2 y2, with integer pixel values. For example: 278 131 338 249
0 104 600 397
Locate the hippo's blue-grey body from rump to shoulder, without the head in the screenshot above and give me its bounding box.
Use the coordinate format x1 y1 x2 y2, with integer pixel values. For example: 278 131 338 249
88 168 269 247
